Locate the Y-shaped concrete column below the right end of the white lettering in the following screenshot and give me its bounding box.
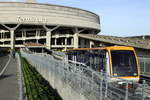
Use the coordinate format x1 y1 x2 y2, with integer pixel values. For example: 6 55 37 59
43 25 60 49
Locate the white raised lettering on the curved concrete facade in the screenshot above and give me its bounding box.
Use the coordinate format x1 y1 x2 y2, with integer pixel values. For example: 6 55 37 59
17 16 47 23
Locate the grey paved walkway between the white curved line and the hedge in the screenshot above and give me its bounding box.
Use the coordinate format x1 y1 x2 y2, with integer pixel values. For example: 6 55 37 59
0 57 19 100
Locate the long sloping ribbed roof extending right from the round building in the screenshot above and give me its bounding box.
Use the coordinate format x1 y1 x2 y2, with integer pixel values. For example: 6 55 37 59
79 34 150 50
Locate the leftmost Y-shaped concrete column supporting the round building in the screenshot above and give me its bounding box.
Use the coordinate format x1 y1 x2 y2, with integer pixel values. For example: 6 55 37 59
1 24 20 49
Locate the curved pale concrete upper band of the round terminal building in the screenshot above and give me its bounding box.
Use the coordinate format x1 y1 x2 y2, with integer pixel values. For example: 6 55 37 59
0 2 100 31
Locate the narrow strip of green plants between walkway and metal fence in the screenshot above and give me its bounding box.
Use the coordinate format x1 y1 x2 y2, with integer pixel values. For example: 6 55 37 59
21 57 62 100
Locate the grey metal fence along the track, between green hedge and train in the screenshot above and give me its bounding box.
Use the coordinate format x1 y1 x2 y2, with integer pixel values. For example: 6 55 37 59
21 51 150 100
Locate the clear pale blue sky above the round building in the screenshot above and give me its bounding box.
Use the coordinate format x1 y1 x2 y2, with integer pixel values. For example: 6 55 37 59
0 0 150 36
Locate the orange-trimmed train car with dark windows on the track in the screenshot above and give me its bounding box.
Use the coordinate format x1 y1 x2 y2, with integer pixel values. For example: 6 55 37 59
67 46 140 82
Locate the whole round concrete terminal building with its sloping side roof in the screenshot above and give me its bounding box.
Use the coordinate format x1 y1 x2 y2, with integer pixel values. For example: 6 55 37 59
0 0 150 55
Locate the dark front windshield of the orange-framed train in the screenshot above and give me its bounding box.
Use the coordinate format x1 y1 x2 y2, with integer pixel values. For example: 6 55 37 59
111 50 138 77
